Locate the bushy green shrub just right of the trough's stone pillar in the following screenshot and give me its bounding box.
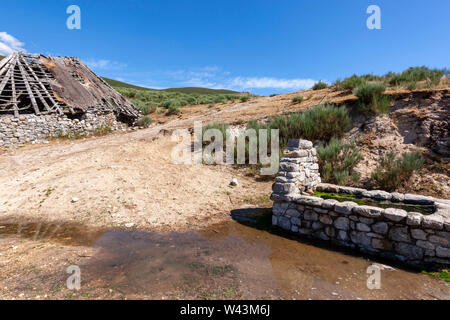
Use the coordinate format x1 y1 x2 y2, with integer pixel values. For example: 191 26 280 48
317 138 363 185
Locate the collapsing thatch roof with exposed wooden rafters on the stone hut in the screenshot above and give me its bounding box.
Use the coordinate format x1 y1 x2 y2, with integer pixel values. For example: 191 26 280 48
0 52 139 122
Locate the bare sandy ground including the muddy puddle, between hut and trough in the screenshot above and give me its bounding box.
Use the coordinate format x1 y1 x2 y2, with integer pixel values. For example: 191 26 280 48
0 84 450 299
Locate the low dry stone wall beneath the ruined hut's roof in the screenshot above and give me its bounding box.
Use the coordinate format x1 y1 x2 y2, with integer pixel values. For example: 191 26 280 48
0 112 125 147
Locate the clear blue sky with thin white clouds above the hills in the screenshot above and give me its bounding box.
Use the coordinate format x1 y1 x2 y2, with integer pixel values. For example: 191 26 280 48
0 0 450 95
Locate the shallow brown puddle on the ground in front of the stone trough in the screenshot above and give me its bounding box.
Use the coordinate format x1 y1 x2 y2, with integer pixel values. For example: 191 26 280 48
0 215 450 299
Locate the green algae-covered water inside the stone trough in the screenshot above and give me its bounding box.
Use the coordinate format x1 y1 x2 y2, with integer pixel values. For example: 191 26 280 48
314 192 436 215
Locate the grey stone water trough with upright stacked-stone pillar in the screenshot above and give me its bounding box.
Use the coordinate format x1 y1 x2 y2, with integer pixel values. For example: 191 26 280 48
271 140 450 267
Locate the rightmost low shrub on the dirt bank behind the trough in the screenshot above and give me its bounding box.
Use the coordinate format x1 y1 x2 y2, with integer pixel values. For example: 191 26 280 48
372 152 424 191
